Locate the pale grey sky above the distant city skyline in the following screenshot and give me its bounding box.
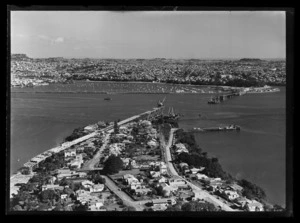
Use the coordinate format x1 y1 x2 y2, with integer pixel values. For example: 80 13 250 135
11 11 286 59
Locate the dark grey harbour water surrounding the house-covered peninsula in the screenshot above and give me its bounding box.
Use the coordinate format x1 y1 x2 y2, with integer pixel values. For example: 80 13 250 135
10 83 285 206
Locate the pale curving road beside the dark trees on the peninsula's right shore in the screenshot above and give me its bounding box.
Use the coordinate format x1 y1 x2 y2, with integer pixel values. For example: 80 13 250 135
164 128 236 211
